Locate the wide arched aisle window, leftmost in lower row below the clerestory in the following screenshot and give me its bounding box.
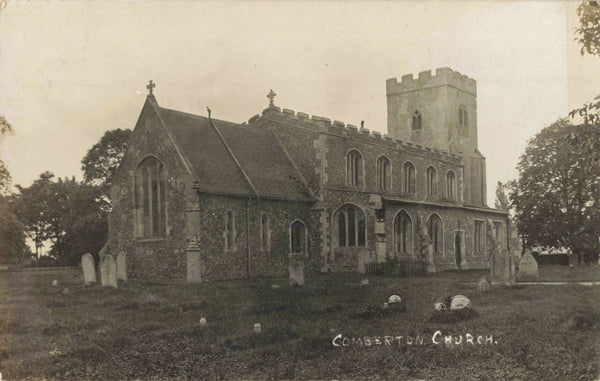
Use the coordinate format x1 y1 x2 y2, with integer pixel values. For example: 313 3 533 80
333 204 367 247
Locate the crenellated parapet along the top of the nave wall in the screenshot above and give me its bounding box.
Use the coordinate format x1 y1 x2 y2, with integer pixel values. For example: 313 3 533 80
248 107 463 164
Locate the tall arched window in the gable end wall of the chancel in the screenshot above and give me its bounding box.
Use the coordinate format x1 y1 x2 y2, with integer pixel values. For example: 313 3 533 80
135 156 167 237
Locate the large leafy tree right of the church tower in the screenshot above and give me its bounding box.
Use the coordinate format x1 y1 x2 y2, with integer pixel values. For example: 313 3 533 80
510 119 600 261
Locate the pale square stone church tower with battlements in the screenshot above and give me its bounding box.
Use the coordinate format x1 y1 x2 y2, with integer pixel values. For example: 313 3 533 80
386 68 486 206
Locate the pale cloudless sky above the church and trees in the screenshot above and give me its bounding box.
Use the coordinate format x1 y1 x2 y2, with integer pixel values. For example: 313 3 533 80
0 0 600 205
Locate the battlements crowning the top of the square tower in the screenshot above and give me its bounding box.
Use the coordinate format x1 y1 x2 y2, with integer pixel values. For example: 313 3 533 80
385 67 477 96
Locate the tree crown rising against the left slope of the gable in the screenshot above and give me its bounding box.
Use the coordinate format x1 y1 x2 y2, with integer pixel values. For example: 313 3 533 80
81 129 131 198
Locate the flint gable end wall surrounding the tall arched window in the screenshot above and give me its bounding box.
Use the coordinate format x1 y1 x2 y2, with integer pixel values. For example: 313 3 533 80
108 102 197 280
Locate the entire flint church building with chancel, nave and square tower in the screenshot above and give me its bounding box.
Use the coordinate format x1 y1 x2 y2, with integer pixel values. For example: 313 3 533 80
106 68 509 281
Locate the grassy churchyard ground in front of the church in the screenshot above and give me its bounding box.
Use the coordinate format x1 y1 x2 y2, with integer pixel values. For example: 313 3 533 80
0 267 600 380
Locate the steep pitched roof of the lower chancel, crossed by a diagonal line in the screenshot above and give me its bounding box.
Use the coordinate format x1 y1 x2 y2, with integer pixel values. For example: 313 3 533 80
155 105 315 201
